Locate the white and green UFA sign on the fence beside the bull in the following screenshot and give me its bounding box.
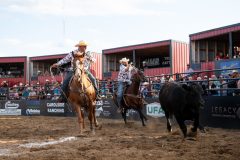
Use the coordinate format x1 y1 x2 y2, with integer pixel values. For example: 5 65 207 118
147 102 165 117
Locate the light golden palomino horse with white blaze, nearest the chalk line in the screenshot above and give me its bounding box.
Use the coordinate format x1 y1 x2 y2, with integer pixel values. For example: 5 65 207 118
68 56 98 134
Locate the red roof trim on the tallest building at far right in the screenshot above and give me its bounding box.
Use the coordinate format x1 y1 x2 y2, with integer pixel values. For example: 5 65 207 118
189 23 240 40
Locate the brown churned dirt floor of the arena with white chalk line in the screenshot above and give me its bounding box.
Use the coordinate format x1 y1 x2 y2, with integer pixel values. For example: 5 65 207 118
0 116 240 160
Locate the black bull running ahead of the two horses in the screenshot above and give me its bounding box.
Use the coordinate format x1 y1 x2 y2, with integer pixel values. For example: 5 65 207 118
159 82 204 137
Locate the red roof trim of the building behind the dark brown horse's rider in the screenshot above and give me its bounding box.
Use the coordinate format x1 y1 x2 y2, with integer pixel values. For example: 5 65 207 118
103 40 171 54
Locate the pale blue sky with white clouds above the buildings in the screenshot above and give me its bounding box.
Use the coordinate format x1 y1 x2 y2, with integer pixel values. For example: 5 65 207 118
0 0 240 57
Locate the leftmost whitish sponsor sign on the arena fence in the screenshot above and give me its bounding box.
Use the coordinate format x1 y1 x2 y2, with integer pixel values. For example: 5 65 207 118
0 101 22 115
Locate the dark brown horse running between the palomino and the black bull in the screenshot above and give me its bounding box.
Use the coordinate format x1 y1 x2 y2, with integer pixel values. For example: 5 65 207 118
113 66 147 126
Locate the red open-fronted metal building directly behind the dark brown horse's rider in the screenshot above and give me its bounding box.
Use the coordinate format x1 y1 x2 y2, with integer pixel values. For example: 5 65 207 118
103 40 189 80
